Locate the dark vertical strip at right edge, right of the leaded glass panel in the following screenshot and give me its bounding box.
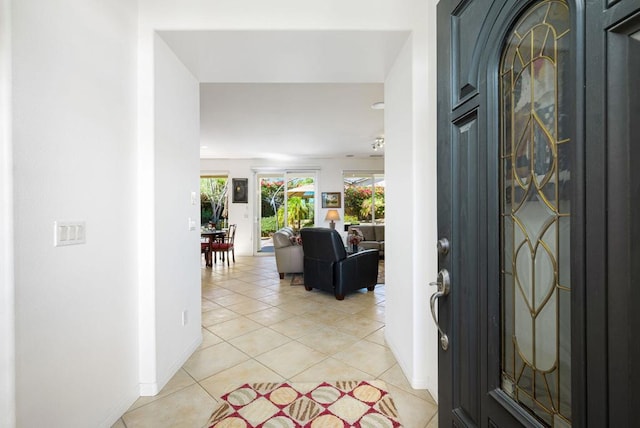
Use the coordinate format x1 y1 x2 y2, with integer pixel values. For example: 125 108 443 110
582 0 640 427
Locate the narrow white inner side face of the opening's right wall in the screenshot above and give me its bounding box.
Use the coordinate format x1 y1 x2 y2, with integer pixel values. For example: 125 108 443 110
384 34 422 380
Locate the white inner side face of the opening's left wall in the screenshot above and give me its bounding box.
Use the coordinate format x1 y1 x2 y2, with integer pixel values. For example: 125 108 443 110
151 36 202 387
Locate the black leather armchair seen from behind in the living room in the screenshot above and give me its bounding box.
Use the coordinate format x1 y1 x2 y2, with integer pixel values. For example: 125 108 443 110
300 227 378 300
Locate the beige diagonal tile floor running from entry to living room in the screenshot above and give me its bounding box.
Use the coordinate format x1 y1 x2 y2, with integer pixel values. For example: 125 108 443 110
113 256 438 428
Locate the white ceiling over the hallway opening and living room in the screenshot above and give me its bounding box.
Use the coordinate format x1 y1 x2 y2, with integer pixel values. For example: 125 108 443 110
159 31 409 159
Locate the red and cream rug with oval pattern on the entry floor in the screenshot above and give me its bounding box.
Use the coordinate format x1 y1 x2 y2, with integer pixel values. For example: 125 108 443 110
207 380 402 428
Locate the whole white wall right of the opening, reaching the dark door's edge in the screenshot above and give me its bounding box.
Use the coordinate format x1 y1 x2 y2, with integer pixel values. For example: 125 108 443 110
385 8 438 399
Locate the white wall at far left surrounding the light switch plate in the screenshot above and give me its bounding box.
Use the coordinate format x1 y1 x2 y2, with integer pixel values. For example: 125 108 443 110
10 0 138 427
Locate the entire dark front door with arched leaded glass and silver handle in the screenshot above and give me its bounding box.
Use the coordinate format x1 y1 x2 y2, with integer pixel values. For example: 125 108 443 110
432 0 640 427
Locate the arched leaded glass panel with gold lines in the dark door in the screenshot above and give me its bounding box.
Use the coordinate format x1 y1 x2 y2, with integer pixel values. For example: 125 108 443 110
500 0 571 427
